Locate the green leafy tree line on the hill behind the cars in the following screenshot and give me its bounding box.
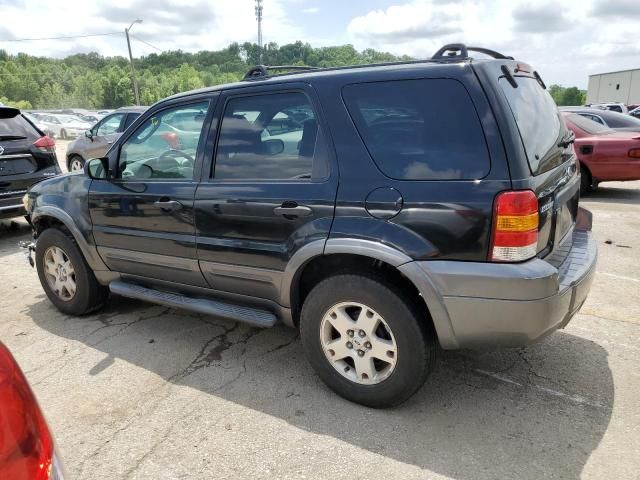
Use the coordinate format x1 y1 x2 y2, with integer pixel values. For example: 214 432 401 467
0 41 584 109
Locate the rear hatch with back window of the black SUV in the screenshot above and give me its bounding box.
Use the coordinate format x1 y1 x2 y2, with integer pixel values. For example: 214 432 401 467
498 69 580 257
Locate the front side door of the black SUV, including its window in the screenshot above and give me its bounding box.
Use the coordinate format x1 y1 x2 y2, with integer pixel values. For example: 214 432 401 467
89 97 213 286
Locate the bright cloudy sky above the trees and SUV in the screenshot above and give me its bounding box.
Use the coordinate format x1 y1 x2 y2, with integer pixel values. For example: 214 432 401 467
0 0 640 88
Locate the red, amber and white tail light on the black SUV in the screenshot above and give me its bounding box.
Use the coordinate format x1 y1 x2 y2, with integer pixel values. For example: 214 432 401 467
489 190 538 262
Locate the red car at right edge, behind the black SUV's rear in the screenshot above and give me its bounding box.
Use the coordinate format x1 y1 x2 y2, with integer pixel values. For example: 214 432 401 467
562 112 640 193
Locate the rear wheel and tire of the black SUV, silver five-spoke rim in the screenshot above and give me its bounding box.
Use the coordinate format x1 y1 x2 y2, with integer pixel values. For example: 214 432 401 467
300 275 436 408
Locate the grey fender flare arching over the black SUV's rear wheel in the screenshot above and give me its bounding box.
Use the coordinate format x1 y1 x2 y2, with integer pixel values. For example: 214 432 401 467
279 238 459 349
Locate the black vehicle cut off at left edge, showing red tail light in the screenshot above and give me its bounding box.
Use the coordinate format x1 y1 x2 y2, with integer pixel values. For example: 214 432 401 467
0 107 61 219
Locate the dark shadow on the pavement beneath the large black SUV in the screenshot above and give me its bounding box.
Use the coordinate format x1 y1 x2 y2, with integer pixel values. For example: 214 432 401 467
26 296 614 480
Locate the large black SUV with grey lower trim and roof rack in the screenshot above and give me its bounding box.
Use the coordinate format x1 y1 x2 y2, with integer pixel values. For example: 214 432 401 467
23 44 596 407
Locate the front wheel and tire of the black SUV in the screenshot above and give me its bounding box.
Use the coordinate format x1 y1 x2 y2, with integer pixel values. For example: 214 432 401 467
36 228 109 315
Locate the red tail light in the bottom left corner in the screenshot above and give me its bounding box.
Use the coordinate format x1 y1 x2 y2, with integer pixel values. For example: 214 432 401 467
0 343 62 480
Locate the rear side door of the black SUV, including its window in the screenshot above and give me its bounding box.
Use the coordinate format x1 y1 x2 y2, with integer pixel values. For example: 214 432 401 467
195 84 337 301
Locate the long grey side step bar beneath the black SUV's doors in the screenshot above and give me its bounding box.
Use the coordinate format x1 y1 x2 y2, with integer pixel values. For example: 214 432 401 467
109 280 277 327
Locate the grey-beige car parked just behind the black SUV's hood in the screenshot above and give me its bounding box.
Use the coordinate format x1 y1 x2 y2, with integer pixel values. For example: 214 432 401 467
67 107 147 172
